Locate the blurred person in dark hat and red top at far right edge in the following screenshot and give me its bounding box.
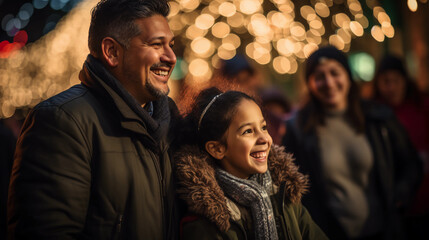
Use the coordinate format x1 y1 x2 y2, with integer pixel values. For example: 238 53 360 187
374 55 429 239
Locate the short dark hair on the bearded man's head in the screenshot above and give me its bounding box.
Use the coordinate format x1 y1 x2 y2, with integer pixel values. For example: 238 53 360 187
88 0 170 56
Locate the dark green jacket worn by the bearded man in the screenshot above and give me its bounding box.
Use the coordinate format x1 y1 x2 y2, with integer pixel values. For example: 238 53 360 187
8 55 179 239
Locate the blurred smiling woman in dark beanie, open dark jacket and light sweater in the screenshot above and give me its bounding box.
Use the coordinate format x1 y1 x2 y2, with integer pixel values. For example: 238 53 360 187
283 46 420 239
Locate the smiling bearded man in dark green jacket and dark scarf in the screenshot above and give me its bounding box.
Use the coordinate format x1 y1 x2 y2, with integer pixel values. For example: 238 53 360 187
8 0 177 239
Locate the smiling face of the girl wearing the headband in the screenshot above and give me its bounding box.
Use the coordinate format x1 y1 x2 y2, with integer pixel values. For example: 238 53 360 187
220 99 273 178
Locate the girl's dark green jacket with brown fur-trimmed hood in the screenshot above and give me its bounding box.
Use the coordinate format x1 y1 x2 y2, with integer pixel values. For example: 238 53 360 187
176 146 327 240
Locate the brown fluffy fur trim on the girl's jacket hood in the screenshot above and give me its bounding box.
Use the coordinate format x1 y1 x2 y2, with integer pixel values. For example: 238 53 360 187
175 145 308 231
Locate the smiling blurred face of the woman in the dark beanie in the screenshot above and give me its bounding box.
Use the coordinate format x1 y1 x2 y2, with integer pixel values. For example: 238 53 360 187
307 59 350 110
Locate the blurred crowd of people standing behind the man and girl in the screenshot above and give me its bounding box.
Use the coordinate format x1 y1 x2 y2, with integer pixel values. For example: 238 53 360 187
0 46 429 239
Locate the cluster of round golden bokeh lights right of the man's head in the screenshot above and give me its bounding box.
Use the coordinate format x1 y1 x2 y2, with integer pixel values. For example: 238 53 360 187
169 0 395 81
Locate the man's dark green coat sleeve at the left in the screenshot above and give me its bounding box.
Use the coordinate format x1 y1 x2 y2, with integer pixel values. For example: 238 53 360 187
8 106 91 239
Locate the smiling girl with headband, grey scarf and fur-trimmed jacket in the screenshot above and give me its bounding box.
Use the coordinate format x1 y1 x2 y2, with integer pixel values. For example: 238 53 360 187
176 88 326 239
